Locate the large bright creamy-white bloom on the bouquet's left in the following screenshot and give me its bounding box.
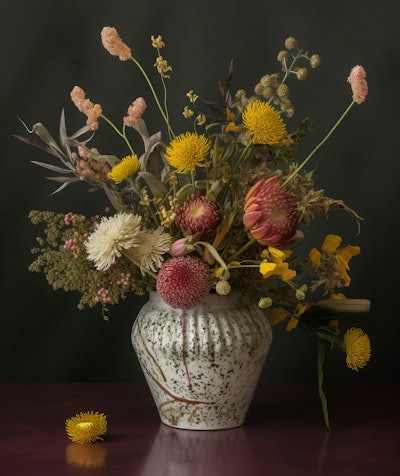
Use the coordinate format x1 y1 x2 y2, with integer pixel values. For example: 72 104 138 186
85 213 141 271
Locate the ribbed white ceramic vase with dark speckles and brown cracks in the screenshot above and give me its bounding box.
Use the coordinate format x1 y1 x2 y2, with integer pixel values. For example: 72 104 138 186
132 293 272 430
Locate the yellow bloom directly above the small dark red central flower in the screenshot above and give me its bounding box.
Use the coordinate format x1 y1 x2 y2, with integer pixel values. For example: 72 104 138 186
165 132 211 174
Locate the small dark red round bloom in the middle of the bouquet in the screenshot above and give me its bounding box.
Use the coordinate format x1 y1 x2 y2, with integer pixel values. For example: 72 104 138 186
175 195 221 235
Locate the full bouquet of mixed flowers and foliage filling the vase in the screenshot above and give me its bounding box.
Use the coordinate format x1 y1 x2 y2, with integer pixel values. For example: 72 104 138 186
17 27 370 424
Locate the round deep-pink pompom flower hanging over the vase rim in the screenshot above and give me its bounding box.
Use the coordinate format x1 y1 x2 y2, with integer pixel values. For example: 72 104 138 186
156 256 211 310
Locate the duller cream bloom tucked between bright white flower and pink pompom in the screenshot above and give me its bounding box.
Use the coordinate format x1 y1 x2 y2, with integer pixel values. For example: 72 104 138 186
128 227 171 275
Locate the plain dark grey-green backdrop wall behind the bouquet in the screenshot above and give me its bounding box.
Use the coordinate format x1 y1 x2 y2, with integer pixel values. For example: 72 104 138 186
0 0 400 382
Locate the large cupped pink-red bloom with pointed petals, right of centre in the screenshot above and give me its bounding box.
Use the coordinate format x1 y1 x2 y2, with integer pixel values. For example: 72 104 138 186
243 175 302 248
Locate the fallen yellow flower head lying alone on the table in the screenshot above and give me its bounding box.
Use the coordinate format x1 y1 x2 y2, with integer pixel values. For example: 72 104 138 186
65 412 107 444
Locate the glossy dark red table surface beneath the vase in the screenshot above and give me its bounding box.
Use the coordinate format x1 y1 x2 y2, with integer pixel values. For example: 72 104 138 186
0 383 400 476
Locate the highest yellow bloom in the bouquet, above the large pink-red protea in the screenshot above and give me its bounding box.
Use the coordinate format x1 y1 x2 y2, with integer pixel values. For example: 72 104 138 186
242 100 286 146
